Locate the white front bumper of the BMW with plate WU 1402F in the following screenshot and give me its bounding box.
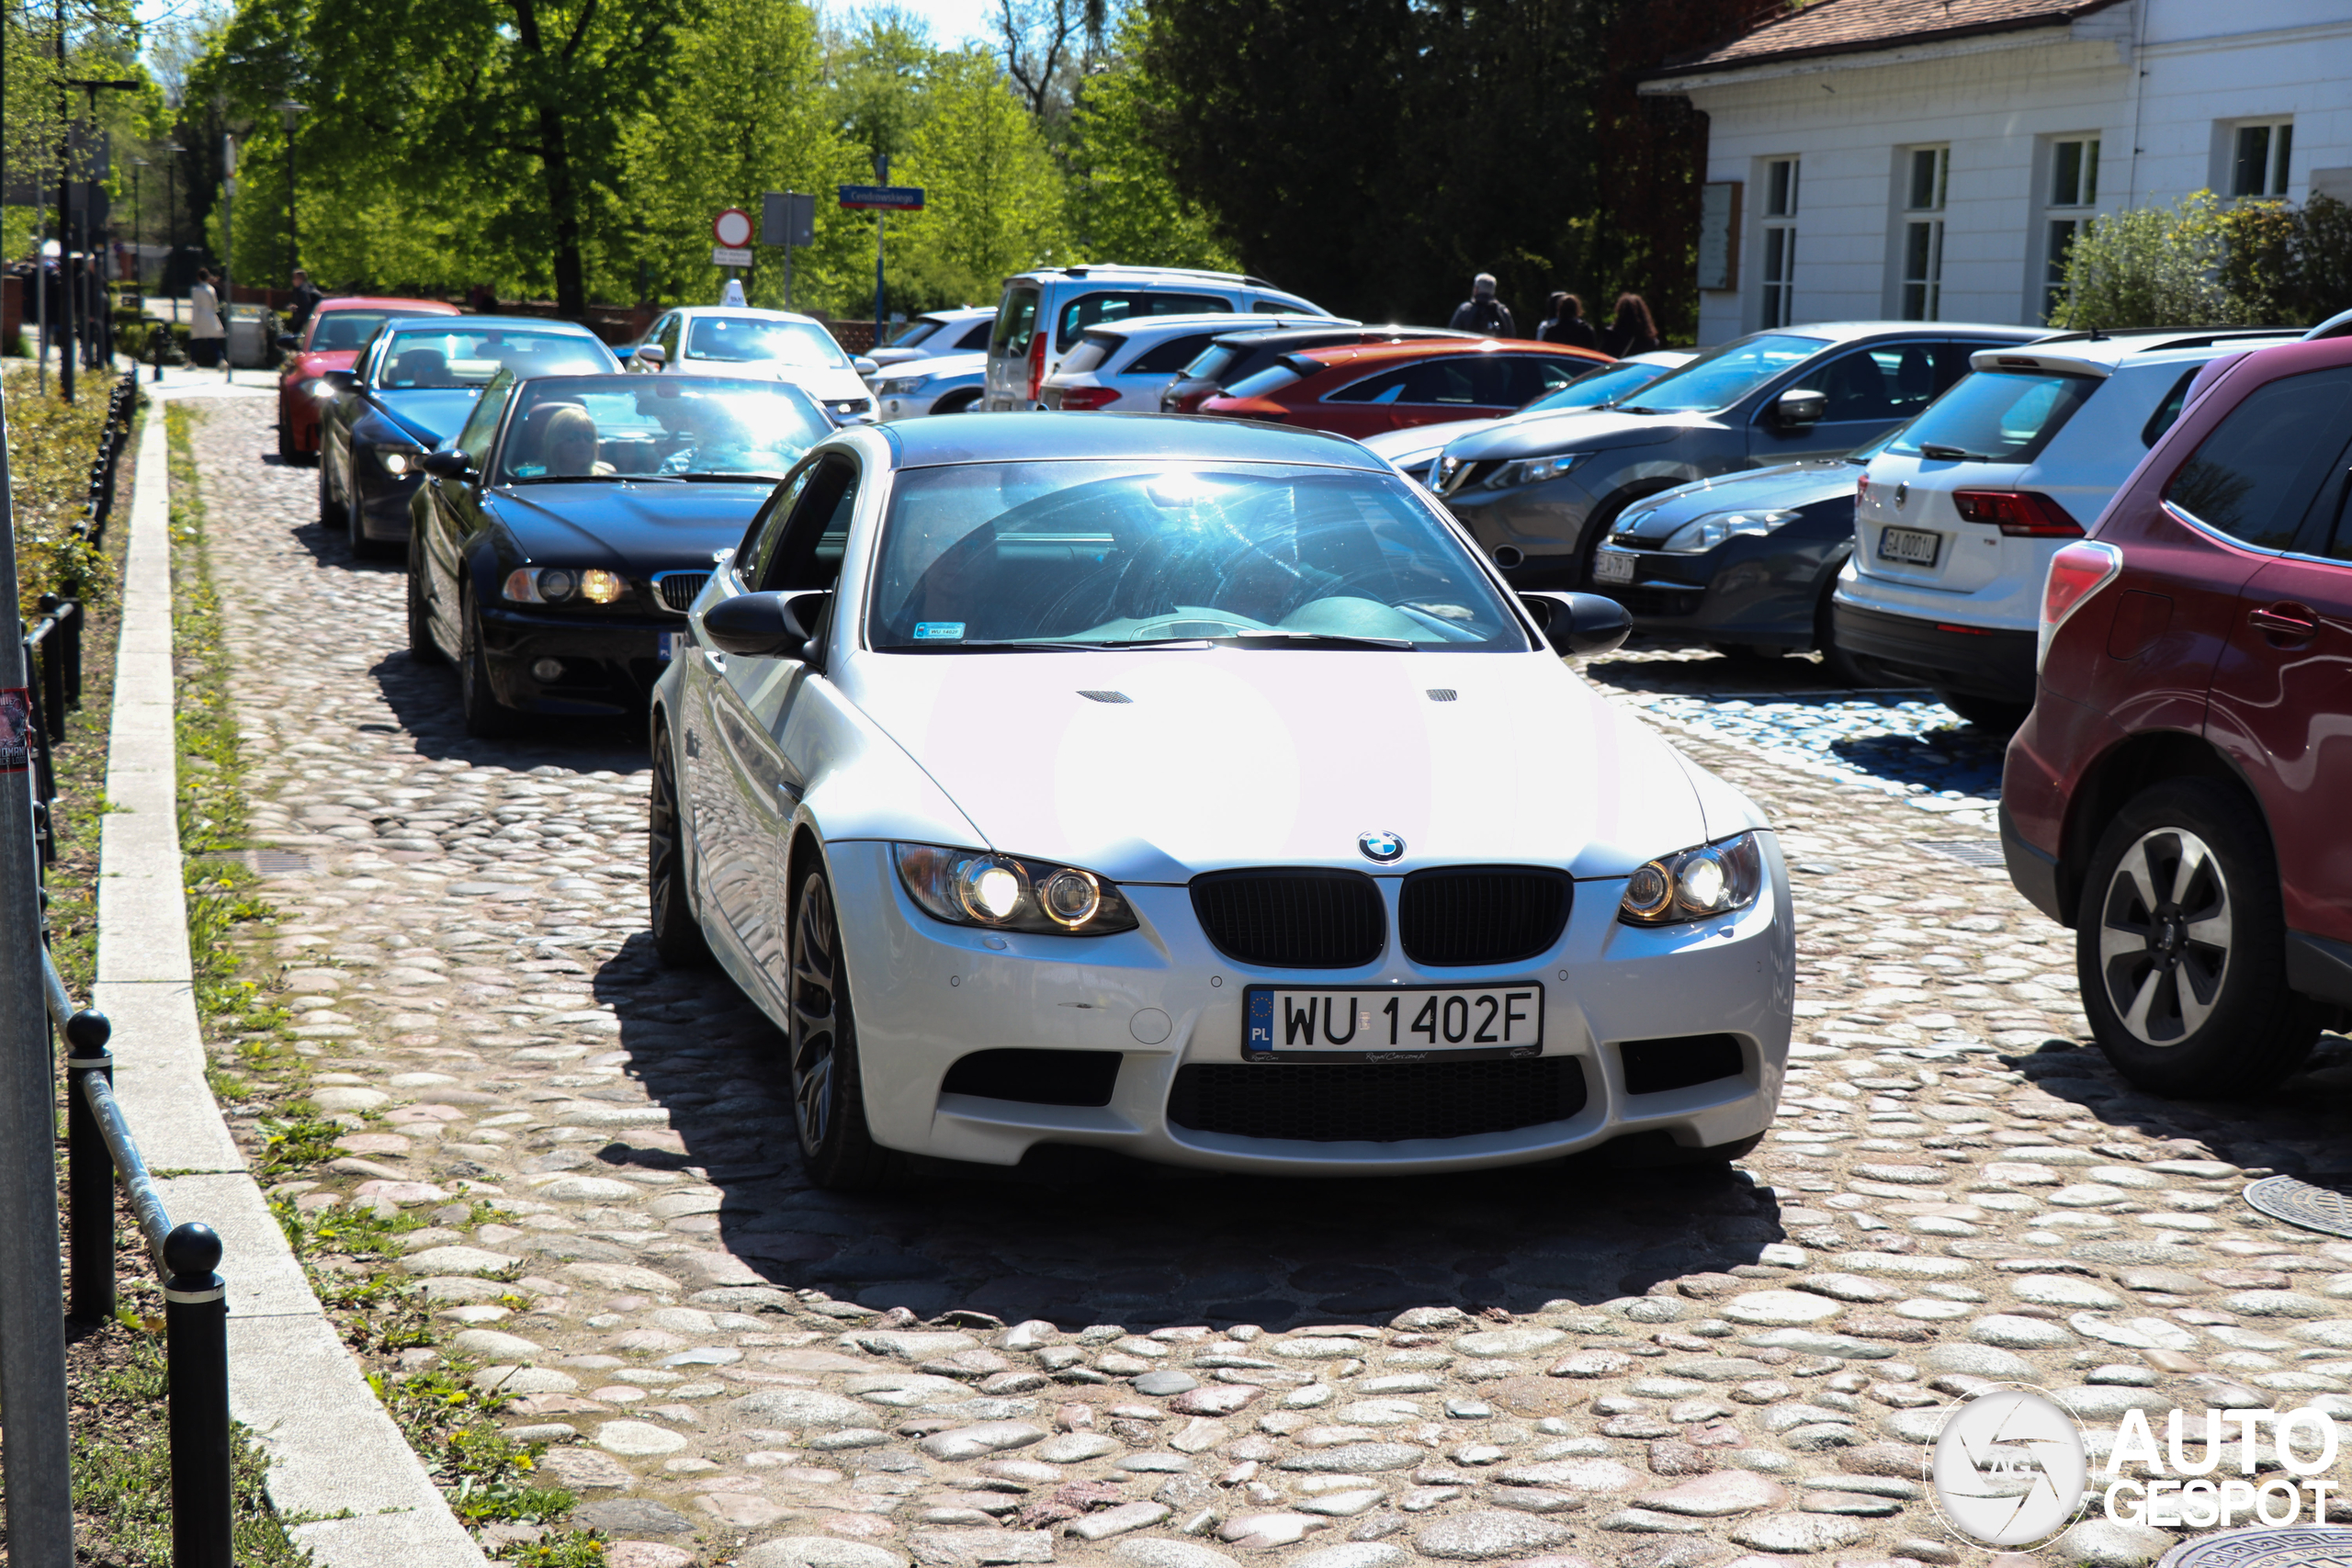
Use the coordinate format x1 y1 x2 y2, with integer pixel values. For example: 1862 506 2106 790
799 835 1794 1176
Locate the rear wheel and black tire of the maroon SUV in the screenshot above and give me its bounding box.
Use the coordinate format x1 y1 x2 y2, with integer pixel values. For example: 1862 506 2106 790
2075 778 2324 1098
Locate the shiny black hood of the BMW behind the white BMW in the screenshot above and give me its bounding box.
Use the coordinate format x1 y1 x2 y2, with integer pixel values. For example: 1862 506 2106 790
484 479 776 576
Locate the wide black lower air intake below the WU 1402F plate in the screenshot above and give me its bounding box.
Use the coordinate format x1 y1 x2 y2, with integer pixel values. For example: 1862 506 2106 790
1169 1055 1585 1143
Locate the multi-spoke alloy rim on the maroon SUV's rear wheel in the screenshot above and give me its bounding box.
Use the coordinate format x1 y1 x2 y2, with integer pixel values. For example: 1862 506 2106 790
2098 828 2232 1046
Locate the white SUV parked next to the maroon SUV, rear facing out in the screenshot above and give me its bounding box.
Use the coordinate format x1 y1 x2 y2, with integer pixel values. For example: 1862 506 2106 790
1832 329 2293 731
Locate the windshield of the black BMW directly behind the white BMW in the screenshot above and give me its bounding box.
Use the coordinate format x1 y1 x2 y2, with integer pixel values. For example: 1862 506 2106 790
492 376 832 484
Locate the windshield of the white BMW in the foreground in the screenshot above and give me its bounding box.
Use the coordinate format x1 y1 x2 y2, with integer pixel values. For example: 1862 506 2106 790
870 461 1529 651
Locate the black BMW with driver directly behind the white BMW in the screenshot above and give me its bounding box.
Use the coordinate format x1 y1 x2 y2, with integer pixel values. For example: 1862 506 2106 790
409 374 832 736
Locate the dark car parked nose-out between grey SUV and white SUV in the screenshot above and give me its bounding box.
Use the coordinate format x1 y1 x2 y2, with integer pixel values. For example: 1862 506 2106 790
1592 425 1900 686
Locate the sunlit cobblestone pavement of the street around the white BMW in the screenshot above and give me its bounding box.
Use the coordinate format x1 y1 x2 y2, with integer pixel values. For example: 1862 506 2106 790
198 389 2352 1568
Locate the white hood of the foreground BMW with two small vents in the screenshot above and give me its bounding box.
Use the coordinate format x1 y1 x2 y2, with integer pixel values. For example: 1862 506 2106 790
842 649 1712 884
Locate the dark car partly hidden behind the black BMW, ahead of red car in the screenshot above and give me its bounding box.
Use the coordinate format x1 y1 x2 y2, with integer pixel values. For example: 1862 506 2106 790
318 315 621 555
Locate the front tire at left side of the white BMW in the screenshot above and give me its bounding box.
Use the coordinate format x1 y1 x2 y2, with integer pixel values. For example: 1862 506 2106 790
786 870 903 1192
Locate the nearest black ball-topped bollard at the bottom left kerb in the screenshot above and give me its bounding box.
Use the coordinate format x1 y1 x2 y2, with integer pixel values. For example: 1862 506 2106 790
163 1220 235 1568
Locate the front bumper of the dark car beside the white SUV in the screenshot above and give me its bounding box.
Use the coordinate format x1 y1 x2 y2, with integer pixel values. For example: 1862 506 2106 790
1590 522 1853 649
